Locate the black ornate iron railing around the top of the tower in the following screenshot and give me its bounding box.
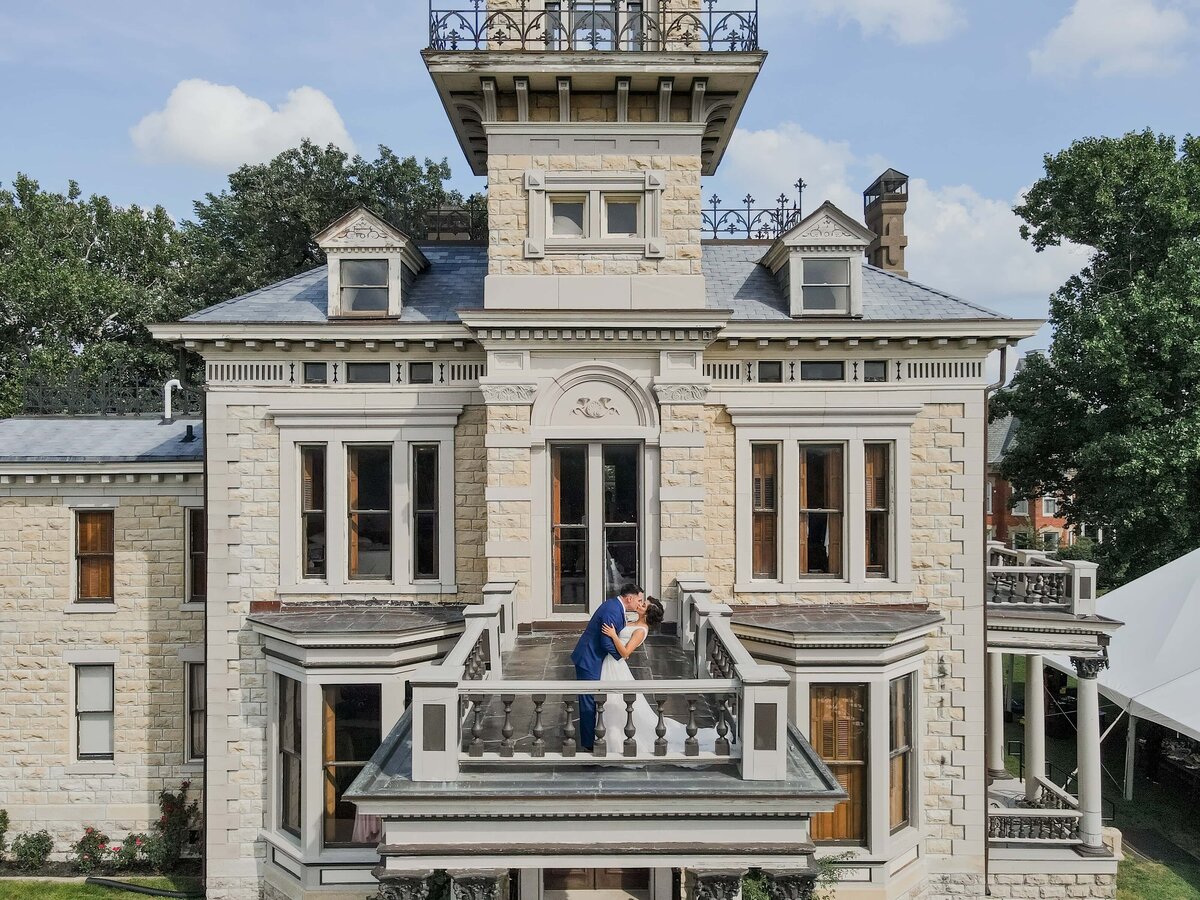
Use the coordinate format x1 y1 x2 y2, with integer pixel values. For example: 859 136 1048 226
430 0 758 53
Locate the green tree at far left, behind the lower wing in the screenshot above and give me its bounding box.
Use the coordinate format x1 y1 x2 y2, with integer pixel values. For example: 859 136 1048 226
0 175 185 415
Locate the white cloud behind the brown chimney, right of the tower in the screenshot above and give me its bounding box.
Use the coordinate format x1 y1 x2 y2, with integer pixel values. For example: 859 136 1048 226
720 122 1087 318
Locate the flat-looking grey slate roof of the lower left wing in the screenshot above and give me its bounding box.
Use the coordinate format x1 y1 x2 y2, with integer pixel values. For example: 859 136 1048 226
0 416 204 464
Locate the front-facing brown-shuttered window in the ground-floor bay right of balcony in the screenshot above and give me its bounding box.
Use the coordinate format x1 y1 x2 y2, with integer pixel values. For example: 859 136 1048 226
809 684 868 844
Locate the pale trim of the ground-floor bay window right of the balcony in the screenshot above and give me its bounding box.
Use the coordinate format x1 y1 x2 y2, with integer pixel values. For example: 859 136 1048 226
792 654 925 866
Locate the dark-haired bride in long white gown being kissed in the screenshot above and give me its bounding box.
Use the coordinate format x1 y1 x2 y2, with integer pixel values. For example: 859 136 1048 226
600 598 716 756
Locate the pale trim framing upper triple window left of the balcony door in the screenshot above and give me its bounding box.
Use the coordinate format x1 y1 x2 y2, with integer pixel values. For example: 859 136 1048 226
277 420 458 595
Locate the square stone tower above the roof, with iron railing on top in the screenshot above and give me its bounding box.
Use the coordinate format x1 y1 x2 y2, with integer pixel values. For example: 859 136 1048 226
424 0 766 311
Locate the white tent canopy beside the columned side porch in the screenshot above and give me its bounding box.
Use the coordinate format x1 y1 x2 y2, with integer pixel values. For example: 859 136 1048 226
1048 550 1200 740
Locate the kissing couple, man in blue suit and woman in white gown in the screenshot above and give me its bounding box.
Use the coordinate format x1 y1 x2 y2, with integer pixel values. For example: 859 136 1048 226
571 584 716 756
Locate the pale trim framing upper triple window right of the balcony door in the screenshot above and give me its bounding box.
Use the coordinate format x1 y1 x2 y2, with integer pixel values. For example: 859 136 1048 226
733 425 912 594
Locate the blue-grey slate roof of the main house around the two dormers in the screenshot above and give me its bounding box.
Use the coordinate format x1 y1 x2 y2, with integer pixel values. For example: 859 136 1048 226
184 241 1007 325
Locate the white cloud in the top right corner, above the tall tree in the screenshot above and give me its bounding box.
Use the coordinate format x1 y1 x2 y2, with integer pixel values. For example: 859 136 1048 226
1030 0 1189 77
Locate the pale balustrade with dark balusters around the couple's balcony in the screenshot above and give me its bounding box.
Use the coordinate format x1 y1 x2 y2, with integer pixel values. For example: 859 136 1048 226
410 582 787 781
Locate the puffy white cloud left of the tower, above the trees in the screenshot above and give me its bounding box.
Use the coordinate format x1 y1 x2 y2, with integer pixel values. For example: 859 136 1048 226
130 78 354 168
